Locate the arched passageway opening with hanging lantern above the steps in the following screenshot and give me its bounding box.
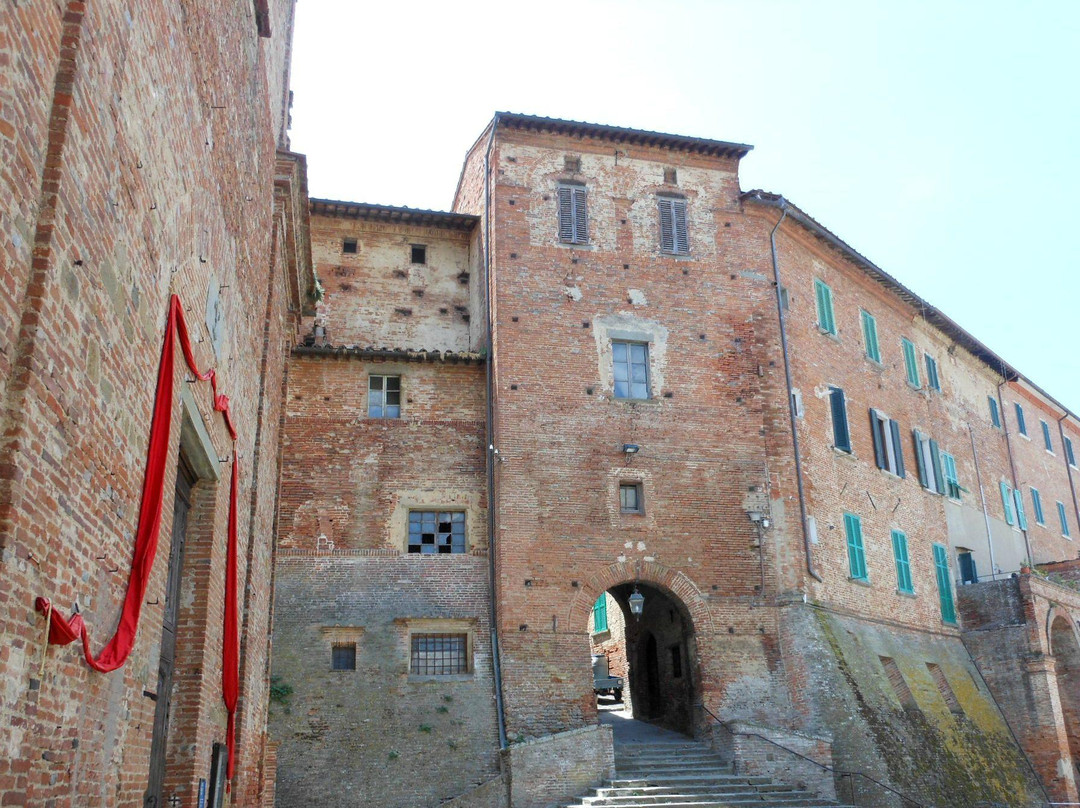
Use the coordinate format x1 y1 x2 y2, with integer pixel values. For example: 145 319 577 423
589 581 700 736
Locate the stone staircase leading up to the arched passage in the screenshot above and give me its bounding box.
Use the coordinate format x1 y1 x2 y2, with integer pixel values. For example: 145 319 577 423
565 741 855 808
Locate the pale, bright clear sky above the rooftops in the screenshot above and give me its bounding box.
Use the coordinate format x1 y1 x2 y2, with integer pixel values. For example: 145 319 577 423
292 0 1080 413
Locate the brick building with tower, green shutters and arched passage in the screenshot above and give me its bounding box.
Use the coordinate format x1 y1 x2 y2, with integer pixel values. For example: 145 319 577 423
271 113 1080 806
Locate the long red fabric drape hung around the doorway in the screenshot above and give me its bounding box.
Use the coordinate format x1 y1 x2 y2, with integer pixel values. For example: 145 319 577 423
36 295 240 780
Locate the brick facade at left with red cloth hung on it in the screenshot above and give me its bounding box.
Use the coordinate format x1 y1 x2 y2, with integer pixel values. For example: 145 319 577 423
0 0 314 808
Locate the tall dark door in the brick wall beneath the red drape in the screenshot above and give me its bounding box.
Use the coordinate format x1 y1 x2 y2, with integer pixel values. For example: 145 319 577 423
143 453 197 808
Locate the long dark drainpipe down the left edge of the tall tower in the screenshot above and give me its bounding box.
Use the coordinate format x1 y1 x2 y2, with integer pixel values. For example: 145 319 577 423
484 112 507 749
